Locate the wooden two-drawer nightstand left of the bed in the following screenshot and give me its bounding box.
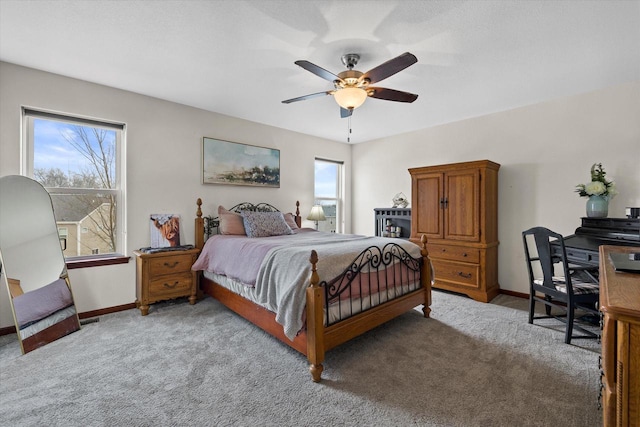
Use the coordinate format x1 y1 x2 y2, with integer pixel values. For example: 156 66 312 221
133 249 200 316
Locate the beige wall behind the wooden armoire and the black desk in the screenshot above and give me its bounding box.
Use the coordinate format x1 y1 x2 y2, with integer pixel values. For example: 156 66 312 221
352 82 640 293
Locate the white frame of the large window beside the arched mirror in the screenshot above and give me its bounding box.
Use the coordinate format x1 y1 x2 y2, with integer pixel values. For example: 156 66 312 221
20 106 130 269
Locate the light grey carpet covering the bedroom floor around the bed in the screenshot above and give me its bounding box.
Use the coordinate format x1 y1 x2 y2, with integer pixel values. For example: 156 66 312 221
0 291 602 427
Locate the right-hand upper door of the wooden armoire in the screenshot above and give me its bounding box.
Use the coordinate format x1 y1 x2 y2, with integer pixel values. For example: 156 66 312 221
444 169 480 242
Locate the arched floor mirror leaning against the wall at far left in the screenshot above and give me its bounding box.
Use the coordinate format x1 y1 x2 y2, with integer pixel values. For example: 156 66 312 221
0 175 80 353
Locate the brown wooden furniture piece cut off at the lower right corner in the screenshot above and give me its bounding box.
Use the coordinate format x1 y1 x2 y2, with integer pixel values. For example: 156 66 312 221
600 246 640 427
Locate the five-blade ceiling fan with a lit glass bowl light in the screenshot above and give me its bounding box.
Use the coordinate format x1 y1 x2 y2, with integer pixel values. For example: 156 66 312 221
282 52 418 118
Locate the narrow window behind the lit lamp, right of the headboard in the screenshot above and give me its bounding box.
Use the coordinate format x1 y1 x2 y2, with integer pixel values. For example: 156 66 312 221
314 159 344 233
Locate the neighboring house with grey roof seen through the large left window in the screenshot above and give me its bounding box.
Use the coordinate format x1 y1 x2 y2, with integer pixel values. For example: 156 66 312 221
51 194 113 257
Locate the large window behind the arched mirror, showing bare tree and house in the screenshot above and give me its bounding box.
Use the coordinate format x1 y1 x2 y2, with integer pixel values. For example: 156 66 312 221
23 109 125 262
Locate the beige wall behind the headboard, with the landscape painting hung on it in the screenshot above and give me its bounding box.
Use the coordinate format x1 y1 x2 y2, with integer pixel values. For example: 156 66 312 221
0 62 351 327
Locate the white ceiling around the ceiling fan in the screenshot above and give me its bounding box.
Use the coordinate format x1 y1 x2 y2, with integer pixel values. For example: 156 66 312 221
0 0 640 143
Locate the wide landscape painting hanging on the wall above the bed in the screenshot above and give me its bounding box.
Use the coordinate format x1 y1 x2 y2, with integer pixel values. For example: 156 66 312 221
202 137 280 188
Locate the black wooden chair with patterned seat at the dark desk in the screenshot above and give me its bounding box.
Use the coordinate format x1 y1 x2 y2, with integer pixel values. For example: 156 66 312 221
522 227 600 344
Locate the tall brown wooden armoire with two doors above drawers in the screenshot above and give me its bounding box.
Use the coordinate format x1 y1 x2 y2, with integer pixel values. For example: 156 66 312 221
409 160 500 302
